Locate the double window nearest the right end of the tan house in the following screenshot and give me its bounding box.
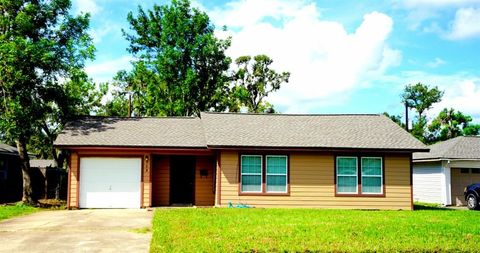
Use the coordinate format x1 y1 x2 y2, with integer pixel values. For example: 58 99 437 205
336 156 383 196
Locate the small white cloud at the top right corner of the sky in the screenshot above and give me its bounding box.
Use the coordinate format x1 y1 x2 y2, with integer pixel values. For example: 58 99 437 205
447 8 480 40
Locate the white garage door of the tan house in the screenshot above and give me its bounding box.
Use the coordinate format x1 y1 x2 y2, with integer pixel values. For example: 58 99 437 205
80 157 142 208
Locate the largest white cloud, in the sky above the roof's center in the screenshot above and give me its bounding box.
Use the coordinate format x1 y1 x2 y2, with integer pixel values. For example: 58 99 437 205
209 0 401 112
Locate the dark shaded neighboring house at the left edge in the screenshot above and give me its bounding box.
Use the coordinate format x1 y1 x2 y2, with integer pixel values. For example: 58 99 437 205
0 143 23 203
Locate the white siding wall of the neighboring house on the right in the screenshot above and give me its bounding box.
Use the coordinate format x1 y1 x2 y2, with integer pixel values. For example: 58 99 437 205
413 162 444 205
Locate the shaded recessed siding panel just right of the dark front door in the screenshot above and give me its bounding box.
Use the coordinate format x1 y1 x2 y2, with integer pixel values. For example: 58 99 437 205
195 156 215 206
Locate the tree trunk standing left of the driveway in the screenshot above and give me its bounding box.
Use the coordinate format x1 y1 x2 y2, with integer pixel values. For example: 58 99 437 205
17 138 37 205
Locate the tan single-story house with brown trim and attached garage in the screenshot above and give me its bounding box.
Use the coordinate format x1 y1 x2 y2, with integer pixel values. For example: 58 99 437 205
55 113 428 210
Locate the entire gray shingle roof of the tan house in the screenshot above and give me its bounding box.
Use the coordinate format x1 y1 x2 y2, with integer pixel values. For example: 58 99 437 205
55 113 427 151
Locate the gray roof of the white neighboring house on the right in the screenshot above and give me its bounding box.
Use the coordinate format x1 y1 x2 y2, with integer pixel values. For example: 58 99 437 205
413 136 480 161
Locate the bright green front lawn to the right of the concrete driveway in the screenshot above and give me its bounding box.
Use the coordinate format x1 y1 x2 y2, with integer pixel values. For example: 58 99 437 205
151 208 480 252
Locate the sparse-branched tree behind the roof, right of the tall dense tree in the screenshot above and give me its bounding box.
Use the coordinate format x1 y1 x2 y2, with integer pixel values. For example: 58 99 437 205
229 55 290 113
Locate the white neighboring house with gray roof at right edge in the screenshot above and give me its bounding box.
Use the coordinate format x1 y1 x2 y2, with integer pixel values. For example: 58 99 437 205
413 136 480 206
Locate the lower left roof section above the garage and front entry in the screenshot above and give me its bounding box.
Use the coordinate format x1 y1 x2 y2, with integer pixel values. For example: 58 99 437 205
55 117 206 148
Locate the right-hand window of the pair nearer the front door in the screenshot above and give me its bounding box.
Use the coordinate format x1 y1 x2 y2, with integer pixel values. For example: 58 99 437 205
266 156 287 192
